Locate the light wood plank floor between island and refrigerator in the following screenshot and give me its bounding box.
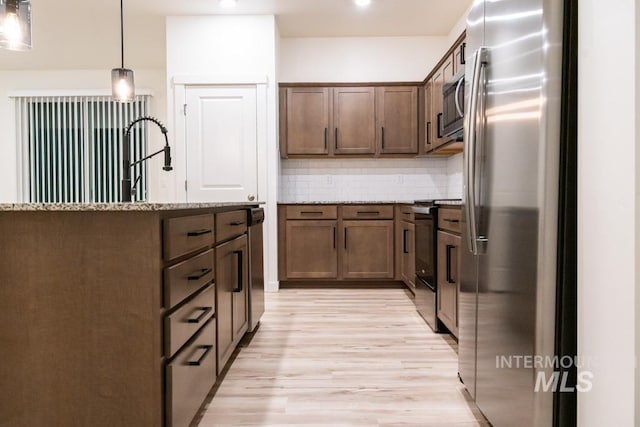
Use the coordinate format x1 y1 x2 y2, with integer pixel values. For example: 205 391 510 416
199 289 488 427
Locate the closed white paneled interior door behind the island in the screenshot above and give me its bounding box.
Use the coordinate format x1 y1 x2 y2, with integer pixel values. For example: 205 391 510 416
186 86 258 202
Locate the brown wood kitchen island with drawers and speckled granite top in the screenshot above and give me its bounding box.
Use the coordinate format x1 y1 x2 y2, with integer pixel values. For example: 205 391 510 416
0 203 257 427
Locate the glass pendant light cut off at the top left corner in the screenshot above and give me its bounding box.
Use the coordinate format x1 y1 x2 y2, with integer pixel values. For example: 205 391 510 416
0 0 31 50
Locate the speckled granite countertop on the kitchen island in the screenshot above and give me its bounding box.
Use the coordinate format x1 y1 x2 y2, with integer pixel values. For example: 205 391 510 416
0 202 263 212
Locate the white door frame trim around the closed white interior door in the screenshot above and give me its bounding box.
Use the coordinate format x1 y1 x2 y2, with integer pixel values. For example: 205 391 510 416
171 75 269 203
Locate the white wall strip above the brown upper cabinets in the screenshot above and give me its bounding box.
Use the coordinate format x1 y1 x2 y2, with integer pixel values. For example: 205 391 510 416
279 37 449 83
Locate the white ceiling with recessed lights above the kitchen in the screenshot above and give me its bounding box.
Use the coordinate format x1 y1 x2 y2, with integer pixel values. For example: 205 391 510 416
0 0 472 70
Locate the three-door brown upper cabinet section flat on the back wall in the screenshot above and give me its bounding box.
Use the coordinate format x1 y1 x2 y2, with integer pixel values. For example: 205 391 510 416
280 83 418 158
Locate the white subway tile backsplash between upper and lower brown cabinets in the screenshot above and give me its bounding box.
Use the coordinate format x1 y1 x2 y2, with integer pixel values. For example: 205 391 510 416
279 155 462 203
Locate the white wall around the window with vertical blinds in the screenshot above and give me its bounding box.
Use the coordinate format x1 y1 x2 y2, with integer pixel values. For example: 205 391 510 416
0 69 166 203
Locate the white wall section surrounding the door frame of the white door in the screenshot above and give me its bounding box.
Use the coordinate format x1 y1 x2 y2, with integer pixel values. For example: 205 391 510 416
166 15 279 290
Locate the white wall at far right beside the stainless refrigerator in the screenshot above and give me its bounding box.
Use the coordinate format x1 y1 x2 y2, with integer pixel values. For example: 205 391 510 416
578 0 640 427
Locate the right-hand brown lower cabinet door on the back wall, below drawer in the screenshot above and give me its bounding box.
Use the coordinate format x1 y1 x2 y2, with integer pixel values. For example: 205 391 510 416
342 220 394 279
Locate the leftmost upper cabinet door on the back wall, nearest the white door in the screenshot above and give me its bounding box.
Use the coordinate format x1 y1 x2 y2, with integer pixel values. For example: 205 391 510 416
281 88 330 155
